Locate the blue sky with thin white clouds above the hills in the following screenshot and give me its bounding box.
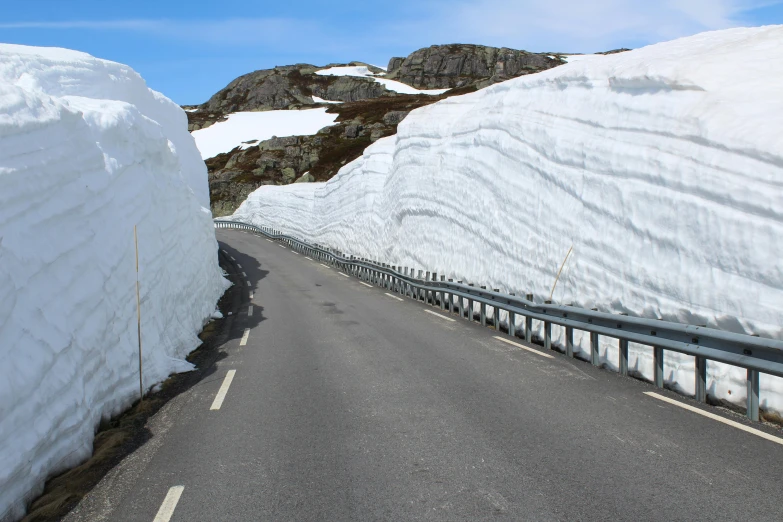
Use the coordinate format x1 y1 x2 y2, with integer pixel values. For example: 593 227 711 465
0 0 783 104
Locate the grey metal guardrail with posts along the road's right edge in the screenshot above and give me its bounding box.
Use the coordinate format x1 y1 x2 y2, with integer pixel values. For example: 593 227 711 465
215 220 783 421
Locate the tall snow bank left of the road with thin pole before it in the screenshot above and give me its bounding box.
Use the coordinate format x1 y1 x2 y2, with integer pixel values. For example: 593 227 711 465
0 45 227 520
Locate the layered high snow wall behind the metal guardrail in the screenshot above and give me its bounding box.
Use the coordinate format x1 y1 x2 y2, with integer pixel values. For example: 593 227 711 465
234 26 783 412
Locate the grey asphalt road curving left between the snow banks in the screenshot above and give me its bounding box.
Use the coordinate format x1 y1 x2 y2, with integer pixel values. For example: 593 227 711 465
66 230 783 522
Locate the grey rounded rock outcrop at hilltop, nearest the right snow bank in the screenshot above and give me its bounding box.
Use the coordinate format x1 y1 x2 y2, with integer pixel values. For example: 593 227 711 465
386 44 563 89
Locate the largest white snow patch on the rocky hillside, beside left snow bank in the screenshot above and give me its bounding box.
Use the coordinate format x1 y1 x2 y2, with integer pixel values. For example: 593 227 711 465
192 107 337 159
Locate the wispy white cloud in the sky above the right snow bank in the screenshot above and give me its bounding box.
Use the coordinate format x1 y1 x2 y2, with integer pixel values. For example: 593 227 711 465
386 0 781 52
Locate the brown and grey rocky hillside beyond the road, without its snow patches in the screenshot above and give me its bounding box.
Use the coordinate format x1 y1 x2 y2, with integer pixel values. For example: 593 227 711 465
188 45 576 216
